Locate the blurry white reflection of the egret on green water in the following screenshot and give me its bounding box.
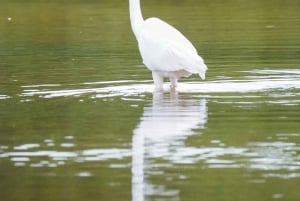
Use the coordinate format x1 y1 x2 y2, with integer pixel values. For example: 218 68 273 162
132 91 207 201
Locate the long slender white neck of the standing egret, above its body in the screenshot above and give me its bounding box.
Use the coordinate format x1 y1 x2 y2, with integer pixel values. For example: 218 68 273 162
129 0 144 36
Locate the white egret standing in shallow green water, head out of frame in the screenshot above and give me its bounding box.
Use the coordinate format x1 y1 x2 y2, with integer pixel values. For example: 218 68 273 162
129 0 207 89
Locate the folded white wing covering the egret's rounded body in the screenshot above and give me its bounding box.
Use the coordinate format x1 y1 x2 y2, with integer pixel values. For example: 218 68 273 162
137 18 206 73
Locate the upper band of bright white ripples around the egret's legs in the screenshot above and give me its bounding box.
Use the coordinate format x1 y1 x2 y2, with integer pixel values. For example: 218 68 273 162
21 79 300 98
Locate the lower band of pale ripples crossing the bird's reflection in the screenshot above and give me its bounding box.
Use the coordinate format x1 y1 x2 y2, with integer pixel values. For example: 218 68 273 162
0 138 300 171
